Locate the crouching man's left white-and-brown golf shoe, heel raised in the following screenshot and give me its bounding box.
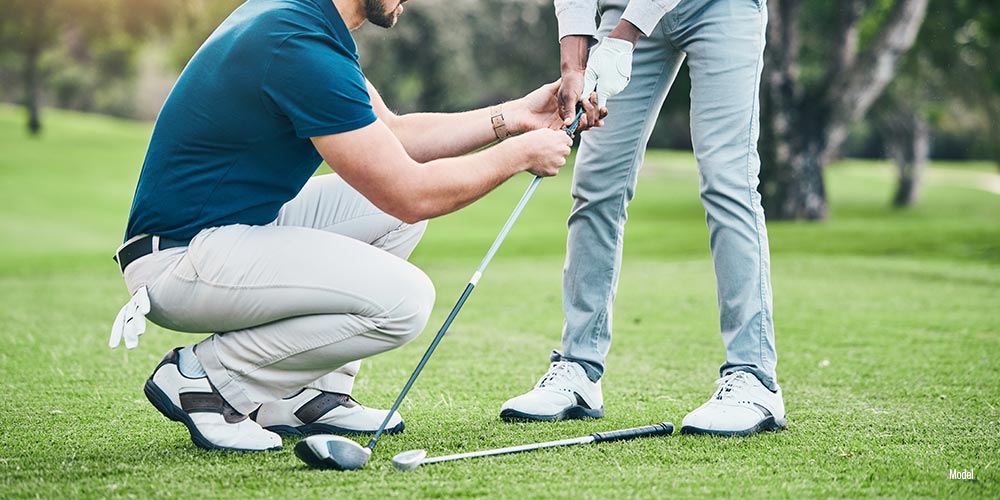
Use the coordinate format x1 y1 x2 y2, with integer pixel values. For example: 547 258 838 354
144 348 281 451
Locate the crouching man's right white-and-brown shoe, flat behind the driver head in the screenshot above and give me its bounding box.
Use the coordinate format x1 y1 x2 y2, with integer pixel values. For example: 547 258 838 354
250 389 404 436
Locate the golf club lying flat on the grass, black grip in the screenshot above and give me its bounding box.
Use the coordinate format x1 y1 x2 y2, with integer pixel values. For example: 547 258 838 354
392 422 674 472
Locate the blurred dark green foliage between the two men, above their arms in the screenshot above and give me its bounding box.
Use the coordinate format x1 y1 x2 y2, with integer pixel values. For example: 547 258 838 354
355 0 559 112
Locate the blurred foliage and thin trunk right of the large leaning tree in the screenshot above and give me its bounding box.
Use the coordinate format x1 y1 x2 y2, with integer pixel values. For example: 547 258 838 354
855 0 1000 207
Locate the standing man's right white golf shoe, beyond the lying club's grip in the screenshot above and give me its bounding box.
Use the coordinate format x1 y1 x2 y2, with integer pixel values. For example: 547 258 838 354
681 371 787 436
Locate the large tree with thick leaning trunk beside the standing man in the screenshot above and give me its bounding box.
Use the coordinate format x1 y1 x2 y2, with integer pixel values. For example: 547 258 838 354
761 0 927 220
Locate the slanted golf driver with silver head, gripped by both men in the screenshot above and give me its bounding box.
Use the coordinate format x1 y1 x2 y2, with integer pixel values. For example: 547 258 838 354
295 105 583 470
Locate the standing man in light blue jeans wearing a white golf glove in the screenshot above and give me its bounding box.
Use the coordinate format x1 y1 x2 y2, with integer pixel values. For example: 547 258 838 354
500 0 785 435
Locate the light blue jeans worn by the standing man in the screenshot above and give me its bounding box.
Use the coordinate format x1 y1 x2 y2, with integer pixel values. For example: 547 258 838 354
552 0 778 390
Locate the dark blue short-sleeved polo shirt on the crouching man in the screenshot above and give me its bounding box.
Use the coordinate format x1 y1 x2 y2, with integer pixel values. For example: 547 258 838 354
125 0 376 239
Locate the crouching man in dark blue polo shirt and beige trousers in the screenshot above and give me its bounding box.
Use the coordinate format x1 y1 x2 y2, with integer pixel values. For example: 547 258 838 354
111 0 594 451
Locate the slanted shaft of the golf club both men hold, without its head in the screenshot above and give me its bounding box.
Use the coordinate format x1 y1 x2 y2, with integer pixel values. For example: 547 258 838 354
367 106 583 450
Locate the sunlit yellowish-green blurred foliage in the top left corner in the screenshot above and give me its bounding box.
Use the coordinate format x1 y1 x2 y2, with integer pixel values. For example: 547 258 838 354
0 0 171 134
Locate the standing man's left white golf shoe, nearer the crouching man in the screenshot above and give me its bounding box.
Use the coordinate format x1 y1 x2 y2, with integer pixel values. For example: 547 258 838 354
500 361 604 422
